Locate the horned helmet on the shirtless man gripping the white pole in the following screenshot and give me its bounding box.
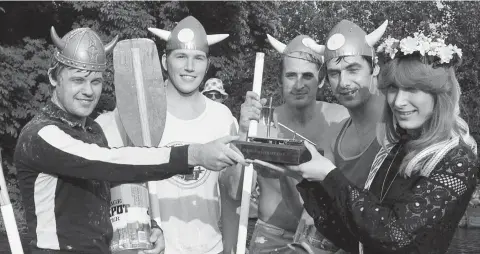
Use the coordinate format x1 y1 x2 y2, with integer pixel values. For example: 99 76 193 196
267 34 325 62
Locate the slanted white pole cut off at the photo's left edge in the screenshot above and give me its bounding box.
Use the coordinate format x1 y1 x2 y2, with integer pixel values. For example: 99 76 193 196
0 151 23 254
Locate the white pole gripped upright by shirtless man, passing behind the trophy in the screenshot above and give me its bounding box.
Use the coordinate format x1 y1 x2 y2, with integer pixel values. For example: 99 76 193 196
237 52 265 254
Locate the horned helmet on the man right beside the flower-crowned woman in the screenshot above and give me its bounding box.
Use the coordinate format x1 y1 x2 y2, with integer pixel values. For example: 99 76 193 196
325 20 388 61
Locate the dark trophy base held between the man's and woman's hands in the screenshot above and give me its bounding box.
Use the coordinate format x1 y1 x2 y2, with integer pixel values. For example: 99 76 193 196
232 137 323 165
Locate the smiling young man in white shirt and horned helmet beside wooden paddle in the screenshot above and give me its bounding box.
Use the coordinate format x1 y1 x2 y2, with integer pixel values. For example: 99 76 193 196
95 16 240 254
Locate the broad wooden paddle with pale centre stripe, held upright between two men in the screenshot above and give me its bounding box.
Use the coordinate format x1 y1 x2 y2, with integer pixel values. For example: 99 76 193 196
113 39 167 222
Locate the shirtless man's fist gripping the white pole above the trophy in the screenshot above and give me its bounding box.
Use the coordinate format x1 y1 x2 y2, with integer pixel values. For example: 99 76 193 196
238 91 267 139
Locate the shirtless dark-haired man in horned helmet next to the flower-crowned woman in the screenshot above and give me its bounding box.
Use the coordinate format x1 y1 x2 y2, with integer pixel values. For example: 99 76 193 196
299 20 388 251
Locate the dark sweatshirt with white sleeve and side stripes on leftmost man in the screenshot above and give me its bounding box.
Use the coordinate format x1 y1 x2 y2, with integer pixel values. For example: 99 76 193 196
14 102 192 254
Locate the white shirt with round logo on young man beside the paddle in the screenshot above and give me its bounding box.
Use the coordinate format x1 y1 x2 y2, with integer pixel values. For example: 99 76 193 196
96 99 235 254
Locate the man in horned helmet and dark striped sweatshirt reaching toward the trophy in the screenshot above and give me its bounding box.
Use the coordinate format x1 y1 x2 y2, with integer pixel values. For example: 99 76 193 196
14 27 248 253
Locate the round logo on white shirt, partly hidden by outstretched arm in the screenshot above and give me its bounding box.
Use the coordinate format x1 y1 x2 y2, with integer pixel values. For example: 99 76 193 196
166 141 210 188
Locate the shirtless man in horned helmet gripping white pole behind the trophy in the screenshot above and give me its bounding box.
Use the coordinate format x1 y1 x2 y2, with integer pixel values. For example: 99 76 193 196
239 35 348 253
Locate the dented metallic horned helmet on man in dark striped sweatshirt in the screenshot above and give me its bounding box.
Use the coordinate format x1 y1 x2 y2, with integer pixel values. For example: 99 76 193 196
50 26 118 71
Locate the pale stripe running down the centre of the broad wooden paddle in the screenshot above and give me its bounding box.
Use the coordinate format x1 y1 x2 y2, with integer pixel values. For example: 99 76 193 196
132 48 160 222
